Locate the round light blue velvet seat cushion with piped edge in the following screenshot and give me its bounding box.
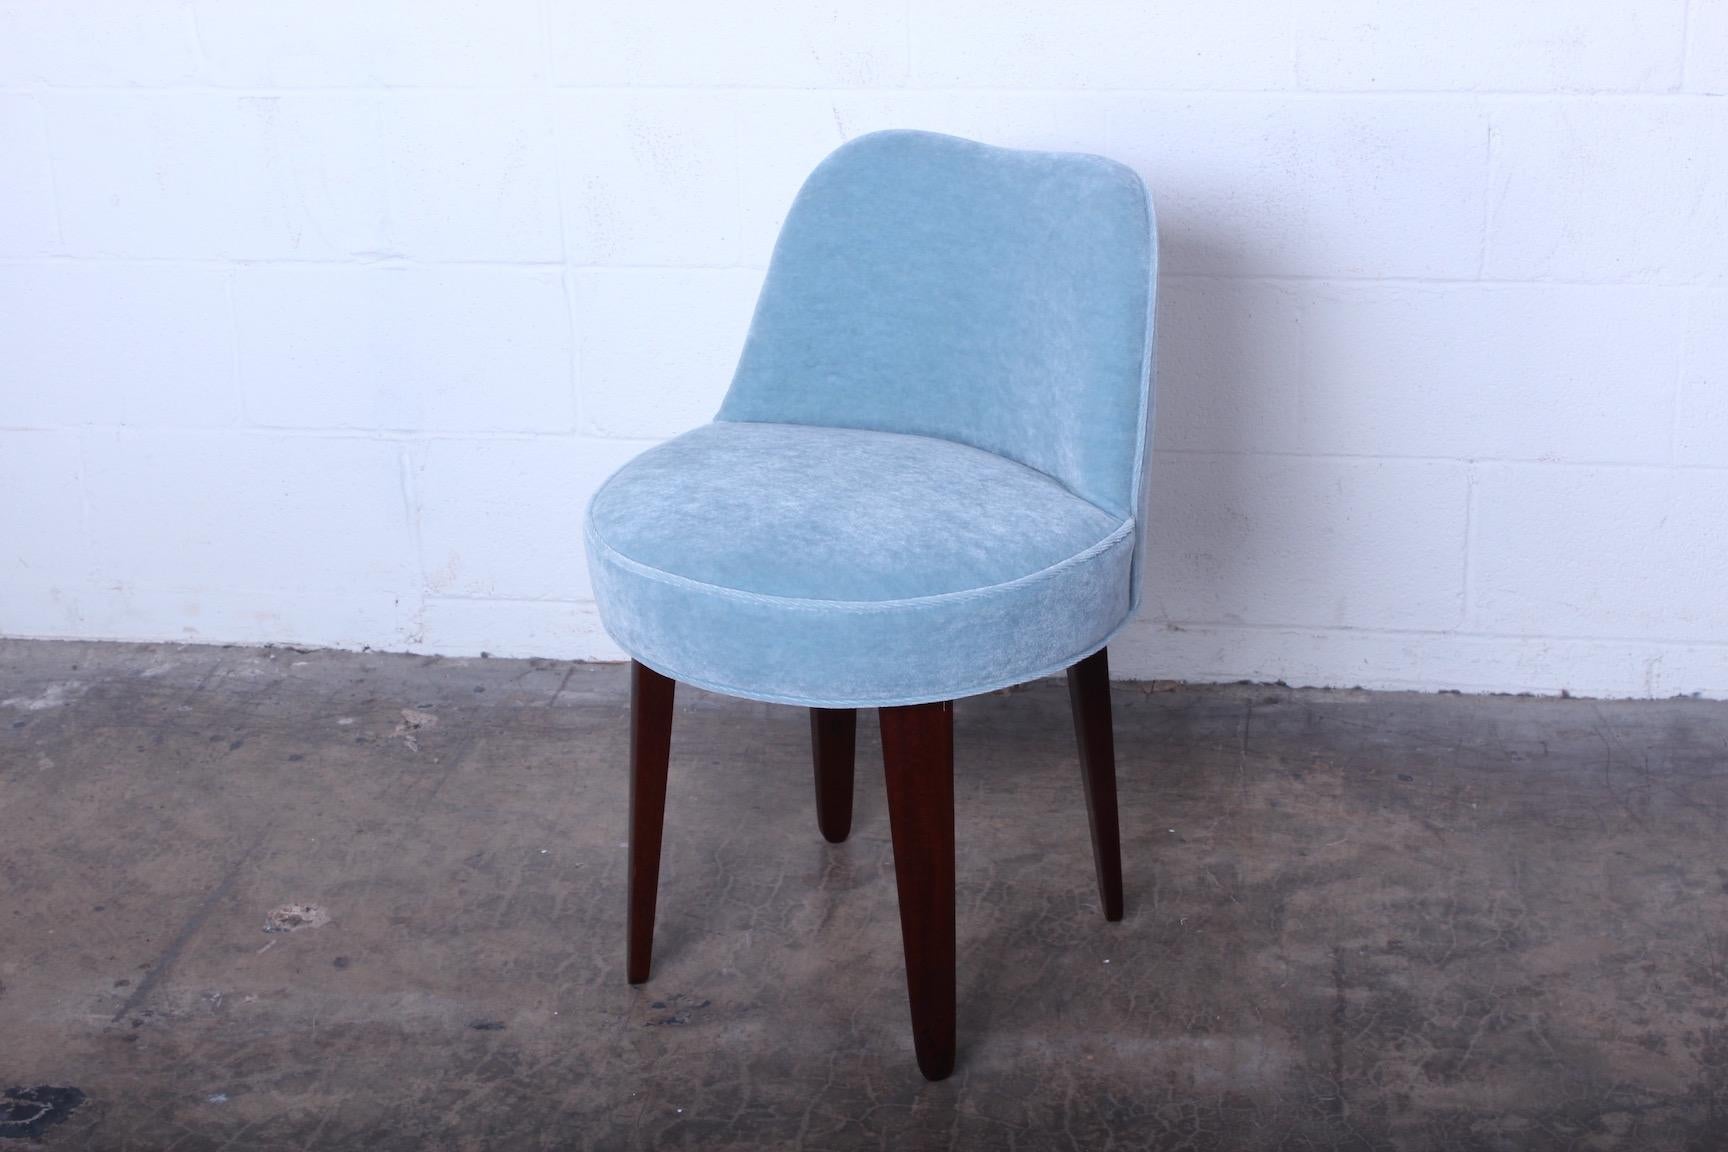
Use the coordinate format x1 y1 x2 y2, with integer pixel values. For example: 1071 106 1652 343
586 421 1134 708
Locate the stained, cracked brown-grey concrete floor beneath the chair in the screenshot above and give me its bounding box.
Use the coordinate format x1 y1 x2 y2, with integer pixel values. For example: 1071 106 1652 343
0 641 1728 1152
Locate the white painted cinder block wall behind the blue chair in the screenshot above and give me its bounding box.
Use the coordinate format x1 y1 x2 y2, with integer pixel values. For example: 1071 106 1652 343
0 0 1728 696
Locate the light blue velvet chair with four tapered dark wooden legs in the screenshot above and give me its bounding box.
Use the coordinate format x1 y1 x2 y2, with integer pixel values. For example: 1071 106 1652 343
586 131 1156 1079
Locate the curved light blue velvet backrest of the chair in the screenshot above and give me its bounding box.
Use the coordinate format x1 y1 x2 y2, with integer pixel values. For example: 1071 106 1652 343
719 131 1156 535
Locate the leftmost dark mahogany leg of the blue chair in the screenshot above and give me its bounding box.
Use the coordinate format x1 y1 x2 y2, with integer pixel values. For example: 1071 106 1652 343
626 660 677 984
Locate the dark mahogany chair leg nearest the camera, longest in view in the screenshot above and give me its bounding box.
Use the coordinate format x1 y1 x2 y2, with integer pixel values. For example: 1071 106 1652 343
881 701 954 1079
